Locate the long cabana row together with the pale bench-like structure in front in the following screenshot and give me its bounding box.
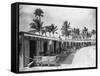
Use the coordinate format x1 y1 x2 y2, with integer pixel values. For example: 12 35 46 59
19 32 95 68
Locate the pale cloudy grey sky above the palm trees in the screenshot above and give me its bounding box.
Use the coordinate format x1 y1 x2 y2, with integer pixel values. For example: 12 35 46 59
19 5 96 34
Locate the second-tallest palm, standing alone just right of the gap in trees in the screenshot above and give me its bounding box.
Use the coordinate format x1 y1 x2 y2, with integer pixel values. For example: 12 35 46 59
61 21 71 37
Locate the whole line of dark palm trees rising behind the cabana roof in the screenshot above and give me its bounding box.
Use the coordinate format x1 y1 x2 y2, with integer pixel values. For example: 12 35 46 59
29 8 96 39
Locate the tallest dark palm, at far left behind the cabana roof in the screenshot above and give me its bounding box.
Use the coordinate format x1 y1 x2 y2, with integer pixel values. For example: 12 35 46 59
30 8 44 34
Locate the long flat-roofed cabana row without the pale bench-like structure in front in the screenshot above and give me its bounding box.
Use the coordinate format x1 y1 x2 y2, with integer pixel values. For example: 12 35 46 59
19 32 95 66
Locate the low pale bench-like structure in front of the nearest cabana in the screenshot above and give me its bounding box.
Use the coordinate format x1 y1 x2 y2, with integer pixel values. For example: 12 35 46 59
25 56 58 67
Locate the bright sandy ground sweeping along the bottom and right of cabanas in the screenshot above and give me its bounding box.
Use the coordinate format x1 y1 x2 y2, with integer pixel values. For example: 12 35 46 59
21 46 96 71
